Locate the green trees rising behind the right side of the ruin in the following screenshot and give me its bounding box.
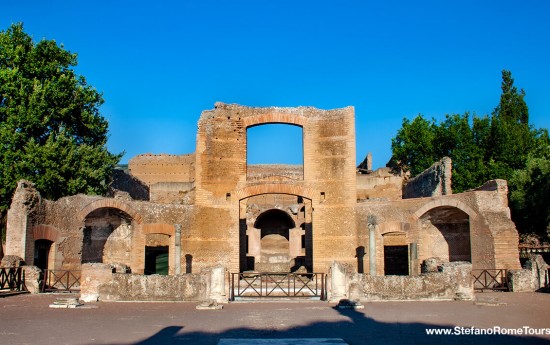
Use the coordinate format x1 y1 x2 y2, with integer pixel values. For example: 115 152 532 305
391 70 550 239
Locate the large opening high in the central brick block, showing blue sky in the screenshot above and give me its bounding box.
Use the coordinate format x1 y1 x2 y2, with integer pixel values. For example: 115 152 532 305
246 123 304 181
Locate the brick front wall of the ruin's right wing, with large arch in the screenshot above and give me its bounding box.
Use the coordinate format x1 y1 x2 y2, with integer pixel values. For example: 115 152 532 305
355 180 520 275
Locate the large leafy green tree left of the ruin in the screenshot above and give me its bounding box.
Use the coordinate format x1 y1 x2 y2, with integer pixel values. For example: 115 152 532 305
0 24 121 212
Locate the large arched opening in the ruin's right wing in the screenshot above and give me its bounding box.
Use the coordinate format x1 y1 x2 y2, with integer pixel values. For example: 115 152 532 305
420 206 472 262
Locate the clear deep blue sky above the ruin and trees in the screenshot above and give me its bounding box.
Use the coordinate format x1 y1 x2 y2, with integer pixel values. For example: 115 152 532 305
0 0 550 168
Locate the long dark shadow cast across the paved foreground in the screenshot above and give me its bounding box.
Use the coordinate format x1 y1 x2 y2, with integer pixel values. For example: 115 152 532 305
105 308 550 345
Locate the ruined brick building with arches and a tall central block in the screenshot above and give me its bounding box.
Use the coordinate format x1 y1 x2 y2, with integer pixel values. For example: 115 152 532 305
5 103 519 298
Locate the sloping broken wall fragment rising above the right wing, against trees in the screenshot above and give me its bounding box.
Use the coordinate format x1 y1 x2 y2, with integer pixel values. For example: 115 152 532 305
403 157 452 199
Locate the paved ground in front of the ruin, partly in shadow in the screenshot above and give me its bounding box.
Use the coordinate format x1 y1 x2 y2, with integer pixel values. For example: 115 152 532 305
0 293 550 345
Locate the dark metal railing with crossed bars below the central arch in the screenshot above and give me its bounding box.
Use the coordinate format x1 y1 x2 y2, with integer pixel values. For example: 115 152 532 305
230 272 326 301
